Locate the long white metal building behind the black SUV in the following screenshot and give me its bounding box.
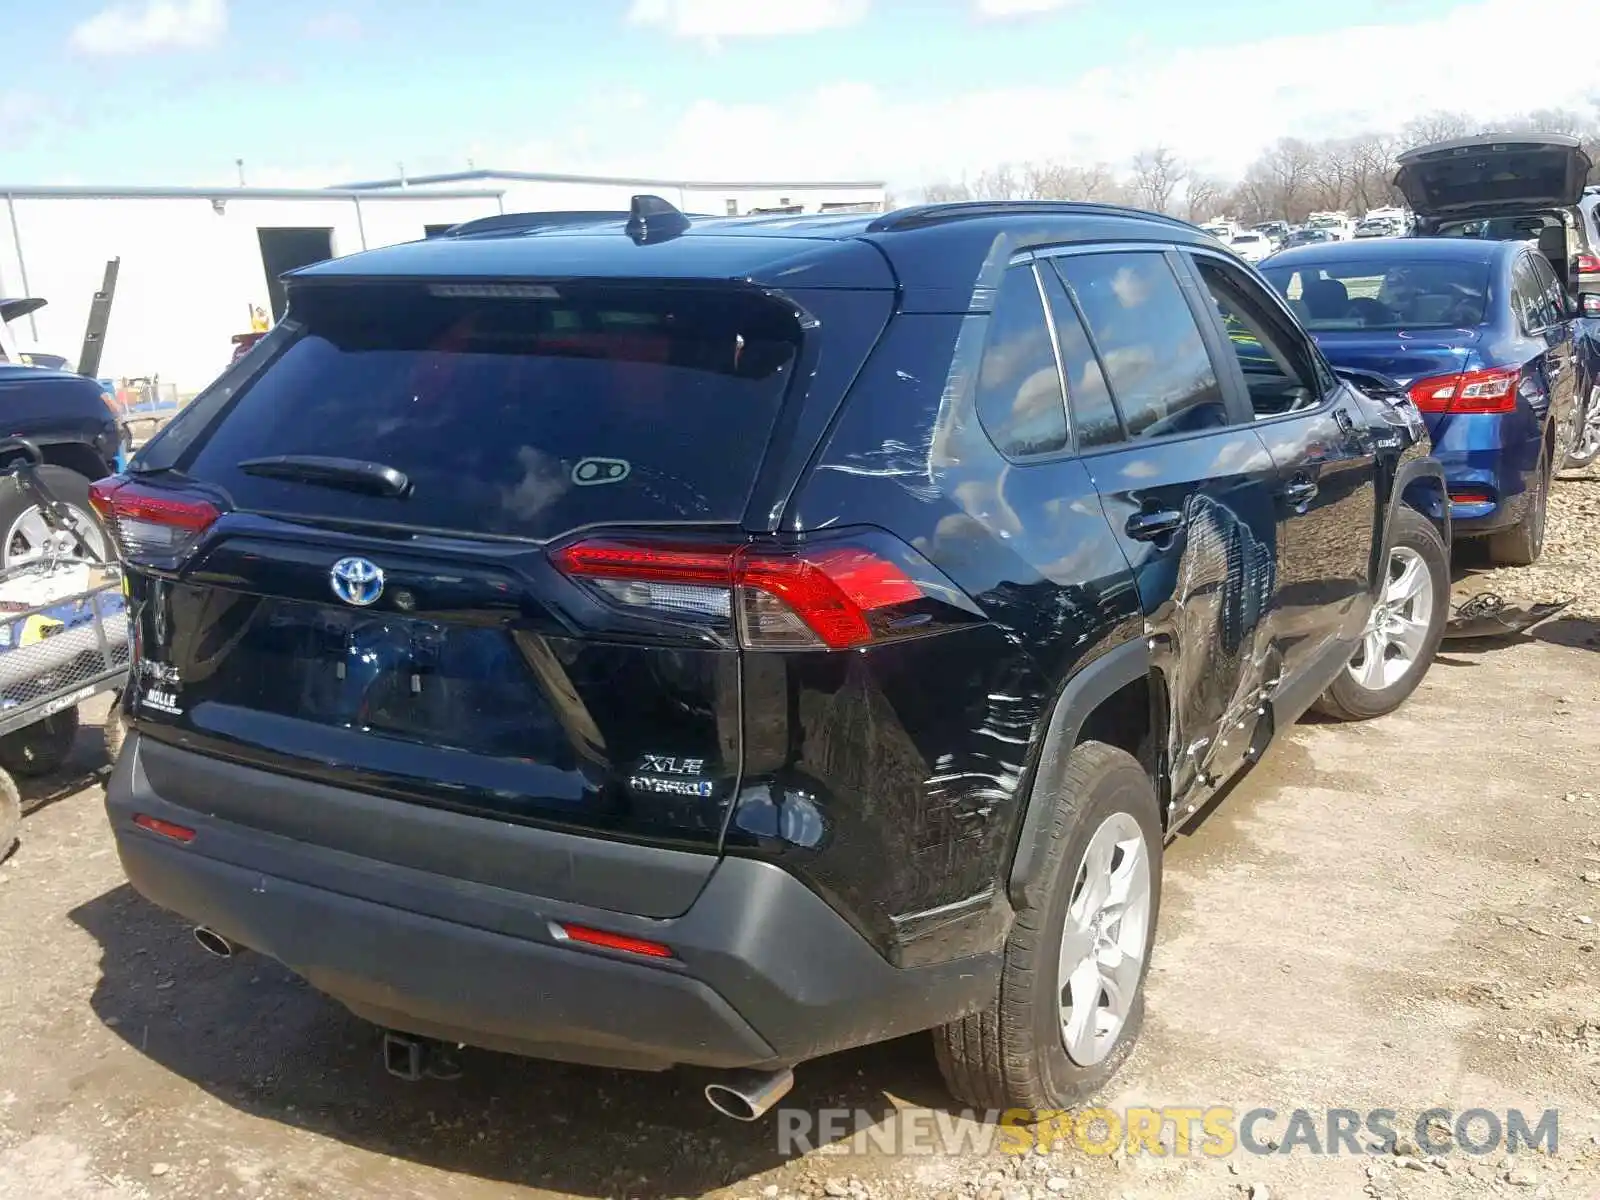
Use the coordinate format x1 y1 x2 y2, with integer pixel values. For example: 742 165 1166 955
0 171 885 395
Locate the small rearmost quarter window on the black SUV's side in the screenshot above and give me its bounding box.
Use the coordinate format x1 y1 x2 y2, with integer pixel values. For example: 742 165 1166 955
978 264 1067 458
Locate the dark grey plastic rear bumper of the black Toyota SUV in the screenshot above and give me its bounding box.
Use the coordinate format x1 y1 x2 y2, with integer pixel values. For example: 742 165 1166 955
106 736 998 1070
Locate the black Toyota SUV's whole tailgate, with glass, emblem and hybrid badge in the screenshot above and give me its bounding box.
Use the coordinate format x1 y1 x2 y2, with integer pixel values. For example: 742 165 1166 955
123 282 890 889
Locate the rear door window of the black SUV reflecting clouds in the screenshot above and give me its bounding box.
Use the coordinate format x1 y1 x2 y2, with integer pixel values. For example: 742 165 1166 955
1054 251 1227 438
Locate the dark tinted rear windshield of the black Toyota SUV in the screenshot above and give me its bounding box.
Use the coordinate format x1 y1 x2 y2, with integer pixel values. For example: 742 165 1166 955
172 283 798 539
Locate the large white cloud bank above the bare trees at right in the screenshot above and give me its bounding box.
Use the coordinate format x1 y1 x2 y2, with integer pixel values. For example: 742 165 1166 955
601 0 1600 189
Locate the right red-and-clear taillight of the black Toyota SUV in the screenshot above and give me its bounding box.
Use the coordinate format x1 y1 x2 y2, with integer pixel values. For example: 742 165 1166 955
552 533 979 650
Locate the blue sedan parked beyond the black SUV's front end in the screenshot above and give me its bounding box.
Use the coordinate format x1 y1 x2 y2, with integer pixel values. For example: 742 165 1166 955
1261 237 1587 565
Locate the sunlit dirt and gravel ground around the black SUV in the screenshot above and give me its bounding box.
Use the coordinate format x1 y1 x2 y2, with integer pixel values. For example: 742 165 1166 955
0 480 1600 1200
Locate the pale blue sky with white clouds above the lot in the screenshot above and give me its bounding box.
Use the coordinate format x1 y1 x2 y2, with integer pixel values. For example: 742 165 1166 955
0 0 1600 190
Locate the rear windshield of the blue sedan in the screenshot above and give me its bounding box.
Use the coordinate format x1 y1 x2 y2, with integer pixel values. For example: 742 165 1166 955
1262 258 1490 330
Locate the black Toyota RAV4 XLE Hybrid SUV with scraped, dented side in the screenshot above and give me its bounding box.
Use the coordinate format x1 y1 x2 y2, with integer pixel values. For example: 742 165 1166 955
94 197 1448 1117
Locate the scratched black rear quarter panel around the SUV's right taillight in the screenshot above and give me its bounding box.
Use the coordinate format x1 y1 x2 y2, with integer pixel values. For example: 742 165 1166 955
726 314 1142 965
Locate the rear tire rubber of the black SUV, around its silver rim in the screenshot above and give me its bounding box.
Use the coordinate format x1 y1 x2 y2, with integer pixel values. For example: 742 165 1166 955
933 742 1162 1109
